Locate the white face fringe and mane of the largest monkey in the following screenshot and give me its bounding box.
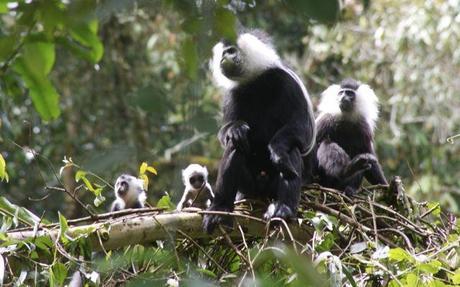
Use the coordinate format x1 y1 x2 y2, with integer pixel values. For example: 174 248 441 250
210 33 282 90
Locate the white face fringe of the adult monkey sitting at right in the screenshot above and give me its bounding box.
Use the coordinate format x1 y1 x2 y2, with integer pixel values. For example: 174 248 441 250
317 84 379 131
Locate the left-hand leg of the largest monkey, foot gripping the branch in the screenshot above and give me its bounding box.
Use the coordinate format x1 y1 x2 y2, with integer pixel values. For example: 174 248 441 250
203 148 254 233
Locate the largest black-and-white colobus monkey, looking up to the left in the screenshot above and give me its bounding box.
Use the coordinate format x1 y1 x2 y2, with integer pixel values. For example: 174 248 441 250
203 31 315 233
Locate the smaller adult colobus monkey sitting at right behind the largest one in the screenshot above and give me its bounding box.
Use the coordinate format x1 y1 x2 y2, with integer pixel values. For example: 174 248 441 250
314 79 387 194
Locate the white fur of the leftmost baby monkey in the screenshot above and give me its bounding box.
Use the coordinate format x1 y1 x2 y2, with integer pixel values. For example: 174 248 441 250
114 174 147 209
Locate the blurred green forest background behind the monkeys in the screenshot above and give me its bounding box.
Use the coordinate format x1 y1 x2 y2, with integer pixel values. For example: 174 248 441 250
0 0 460 219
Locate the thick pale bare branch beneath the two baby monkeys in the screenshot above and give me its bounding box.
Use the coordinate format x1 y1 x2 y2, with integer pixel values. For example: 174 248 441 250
8 211 311 251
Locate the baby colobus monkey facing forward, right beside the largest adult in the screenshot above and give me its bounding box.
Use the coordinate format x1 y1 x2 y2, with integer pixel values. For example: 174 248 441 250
176 164 214 211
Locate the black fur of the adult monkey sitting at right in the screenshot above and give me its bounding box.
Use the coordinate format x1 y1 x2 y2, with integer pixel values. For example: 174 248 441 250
314 80 387 197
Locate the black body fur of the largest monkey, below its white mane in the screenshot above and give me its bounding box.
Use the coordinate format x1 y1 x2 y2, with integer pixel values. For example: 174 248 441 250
203 67 314 232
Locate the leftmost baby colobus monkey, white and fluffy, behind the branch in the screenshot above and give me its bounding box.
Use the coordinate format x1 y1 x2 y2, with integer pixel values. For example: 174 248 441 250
110 174 147 211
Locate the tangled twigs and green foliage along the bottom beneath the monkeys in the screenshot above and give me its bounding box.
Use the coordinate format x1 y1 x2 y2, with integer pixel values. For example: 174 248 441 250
0 186 460 286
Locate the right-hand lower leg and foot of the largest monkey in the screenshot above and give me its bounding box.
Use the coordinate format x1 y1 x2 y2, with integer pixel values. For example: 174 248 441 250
264 148 302 220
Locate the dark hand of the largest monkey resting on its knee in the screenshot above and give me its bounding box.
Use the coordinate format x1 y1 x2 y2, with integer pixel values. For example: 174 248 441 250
217 121 249 152
